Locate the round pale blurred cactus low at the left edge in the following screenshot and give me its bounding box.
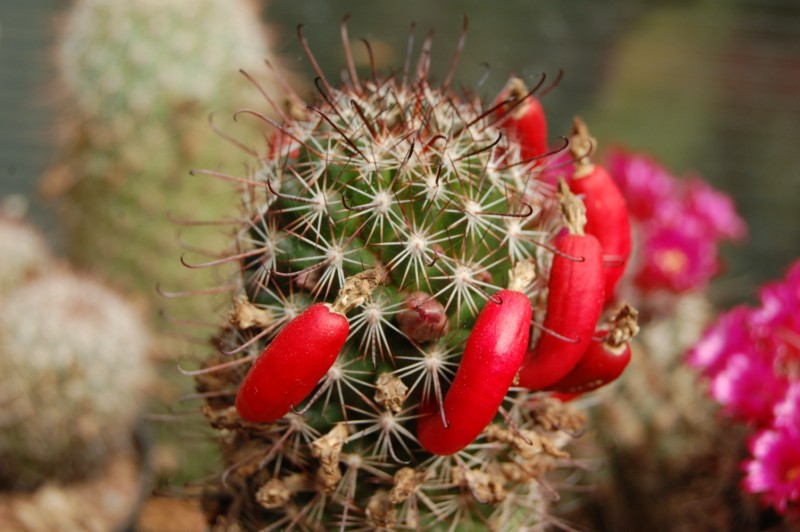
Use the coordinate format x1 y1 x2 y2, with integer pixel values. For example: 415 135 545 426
0 270 152 488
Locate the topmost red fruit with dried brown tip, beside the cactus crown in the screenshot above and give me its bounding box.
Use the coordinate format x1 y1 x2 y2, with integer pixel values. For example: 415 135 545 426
497 78 547 160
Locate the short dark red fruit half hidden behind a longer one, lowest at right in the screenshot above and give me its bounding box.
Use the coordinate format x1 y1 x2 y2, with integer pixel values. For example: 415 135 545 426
550 332 631 394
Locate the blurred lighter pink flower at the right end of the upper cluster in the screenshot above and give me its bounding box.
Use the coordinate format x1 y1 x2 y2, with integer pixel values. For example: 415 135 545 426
686 177 747 240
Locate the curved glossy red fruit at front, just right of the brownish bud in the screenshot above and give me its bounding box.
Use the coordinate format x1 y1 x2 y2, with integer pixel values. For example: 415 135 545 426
417 290 533 455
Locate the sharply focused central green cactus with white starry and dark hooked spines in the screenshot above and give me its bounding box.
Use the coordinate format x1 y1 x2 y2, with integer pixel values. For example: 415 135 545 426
186 25 608 530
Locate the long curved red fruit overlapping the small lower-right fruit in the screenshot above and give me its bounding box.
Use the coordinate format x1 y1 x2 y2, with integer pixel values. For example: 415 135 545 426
519 234 604 390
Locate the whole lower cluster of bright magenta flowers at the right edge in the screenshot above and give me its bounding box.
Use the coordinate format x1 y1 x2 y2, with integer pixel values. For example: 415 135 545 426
688 261 800 513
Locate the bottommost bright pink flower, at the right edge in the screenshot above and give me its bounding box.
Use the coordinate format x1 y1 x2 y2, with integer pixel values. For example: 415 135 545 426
742 429 800 514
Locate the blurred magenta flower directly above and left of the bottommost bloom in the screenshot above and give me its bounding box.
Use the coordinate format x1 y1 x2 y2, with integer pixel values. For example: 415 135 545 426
711 350 789 426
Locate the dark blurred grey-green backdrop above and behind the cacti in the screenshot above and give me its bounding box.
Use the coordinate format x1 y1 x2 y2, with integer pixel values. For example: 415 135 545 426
0 0 800 304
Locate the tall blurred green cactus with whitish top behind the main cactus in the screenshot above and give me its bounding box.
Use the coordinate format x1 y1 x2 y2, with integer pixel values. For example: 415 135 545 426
31 0 298 500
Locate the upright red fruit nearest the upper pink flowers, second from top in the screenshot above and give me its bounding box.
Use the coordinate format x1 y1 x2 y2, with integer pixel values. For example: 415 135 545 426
569 164 631 301
